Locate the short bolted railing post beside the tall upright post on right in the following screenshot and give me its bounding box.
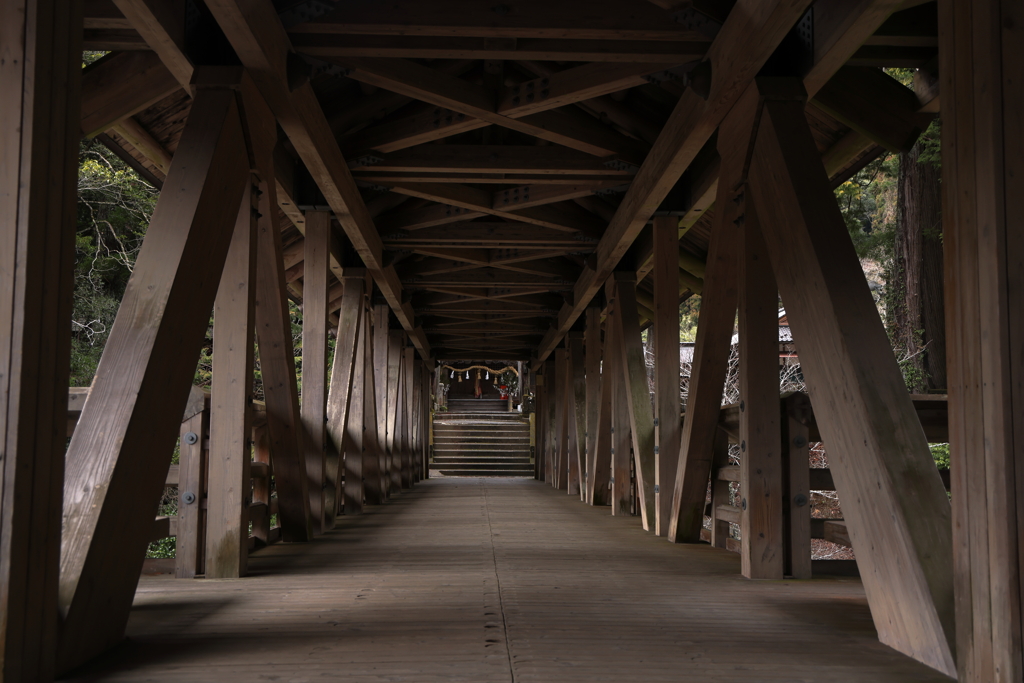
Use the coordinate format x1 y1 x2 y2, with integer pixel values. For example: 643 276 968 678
780 393 811 579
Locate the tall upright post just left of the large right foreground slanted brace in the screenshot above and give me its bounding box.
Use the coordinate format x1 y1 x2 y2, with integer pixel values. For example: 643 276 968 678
737 200 784 579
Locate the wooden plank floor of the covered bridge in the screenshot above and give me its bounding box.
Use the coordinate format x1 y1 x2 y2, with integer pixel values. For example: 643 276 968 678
72 478 951 683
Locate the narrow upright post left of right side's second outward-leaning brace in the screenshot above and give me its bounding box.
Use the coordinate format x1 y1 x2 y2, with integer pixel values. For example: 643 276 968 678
602 286 633 515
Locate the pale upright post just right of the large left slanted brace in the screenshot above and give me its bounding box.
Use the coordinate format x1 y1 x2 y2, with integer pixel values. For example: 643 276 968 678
206 177 259 579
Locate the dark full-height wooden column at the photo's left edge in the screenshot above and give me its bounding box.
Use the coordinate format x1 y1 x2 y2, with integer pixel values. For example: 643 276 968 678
0 0 82 683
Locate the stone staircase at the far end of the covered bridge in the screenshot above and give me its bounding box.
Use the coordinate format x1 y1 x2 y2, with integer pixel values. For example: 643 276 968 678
430 398 534 477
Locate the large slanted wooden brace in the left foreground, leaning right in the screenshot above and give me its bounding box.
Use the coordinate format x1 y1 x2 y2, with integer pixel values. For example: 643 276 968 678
57 81 249 672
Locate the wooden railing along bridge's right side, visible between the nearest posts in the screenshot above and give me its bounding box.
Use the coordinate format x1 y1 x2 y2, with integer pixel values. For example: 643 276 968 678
700 392 949 573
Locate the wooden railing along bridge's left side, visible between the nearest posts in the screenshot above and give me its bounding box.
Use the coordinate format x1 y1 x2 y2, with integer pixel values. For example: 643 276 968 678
68 387 281 579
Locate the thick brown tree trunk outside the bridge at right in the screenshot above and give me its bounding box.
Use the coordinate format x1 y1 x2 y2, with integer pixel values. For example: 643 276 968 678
888 142 946 393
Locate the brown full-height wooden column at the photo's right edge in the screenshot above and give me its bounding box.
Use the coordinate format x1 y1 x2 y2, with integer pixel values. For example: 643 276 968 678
937 0 1024 683
